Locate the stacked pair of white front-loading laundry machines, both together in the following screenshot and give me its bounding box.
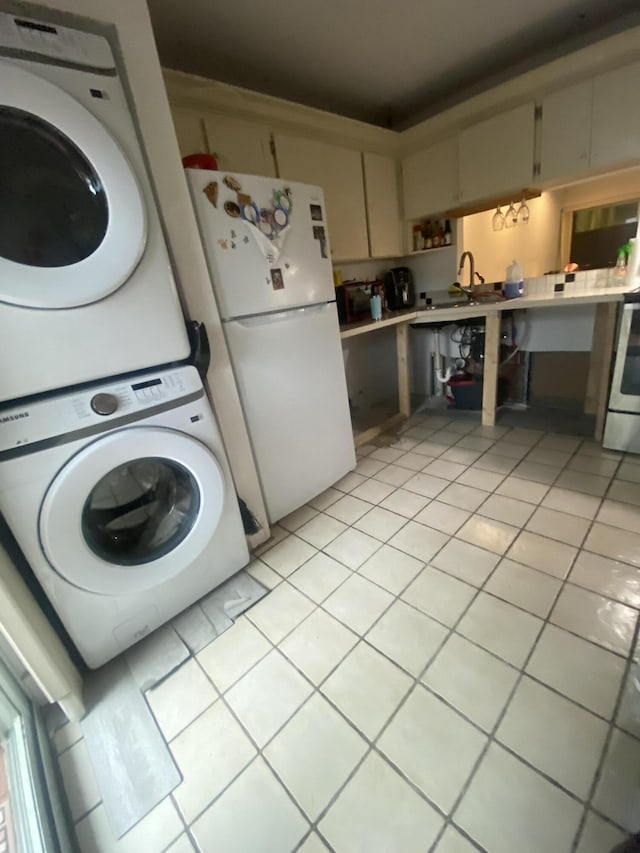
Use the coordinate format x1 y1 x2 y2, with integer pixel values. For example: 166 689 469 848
0 14 249 667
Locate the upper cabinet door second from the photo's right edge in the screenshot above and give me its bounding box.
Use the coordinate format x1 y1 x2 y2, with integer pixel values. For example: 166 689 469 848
537 80 593 181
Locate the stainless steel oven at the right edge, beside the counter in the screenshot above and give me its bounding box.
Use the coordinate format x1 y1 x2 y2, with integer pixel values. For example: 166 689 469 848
602 292 640 453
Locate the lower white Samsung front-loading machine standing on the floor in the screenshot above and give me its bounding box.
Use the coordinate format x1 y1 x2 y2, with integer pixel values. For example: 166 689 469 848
0 366 249 667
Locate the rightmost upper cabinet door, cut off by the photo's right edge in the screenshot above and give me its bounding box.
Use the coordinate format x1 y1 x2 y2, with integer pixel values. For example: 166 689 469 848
591 62 640 167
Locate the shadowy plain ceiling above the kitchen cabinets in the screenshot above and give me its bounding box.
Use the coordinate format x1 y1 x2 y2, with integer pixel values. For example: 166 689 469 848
148 0 638 129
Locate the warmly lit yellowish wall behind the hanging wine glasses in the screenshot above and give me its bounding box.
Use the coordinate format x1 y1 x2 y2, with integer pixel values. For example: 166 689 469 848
462 192 561 284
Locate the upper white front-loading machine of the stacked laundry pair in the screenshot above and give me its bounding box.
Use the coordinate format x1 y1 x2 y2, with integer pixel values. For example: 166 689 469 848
0 14 189 401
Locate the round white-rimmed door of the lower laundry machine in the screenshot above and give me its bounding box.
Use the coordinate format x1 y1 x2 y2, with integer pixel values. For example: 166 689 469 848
39 427 225 595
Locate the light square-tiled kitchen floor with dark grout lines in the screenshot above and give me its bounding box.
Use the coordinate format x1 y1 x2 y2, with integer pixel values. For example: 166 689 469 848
55 414 640 853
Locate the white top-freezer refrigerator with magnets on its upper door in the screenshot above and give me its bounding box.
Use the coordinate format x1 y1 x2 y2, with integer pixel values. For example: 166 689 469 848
186 169 356 523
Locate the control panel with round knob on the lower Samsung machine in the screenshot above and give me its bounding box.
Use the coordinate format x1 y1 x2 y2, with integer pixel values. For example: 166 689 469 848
0 365 204 454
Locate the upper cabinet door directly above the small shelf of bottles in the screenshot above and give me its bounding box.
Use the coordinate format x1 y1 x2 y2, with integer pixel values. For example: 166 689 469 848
402 137 458 219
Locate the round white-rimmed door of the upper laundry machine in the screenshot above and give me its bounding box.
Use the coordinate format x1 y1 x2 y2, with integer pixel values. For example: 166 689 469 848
0 61 147 308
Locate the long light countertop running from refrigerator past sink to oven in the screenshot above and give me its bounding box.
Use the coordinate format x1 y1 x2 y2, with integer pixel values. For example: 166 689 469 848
340 283 629 339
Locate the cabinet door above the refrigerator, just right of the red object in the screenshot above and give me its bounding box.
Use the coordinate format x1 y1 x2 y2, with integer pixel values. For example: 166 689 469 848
204 113 276 178
